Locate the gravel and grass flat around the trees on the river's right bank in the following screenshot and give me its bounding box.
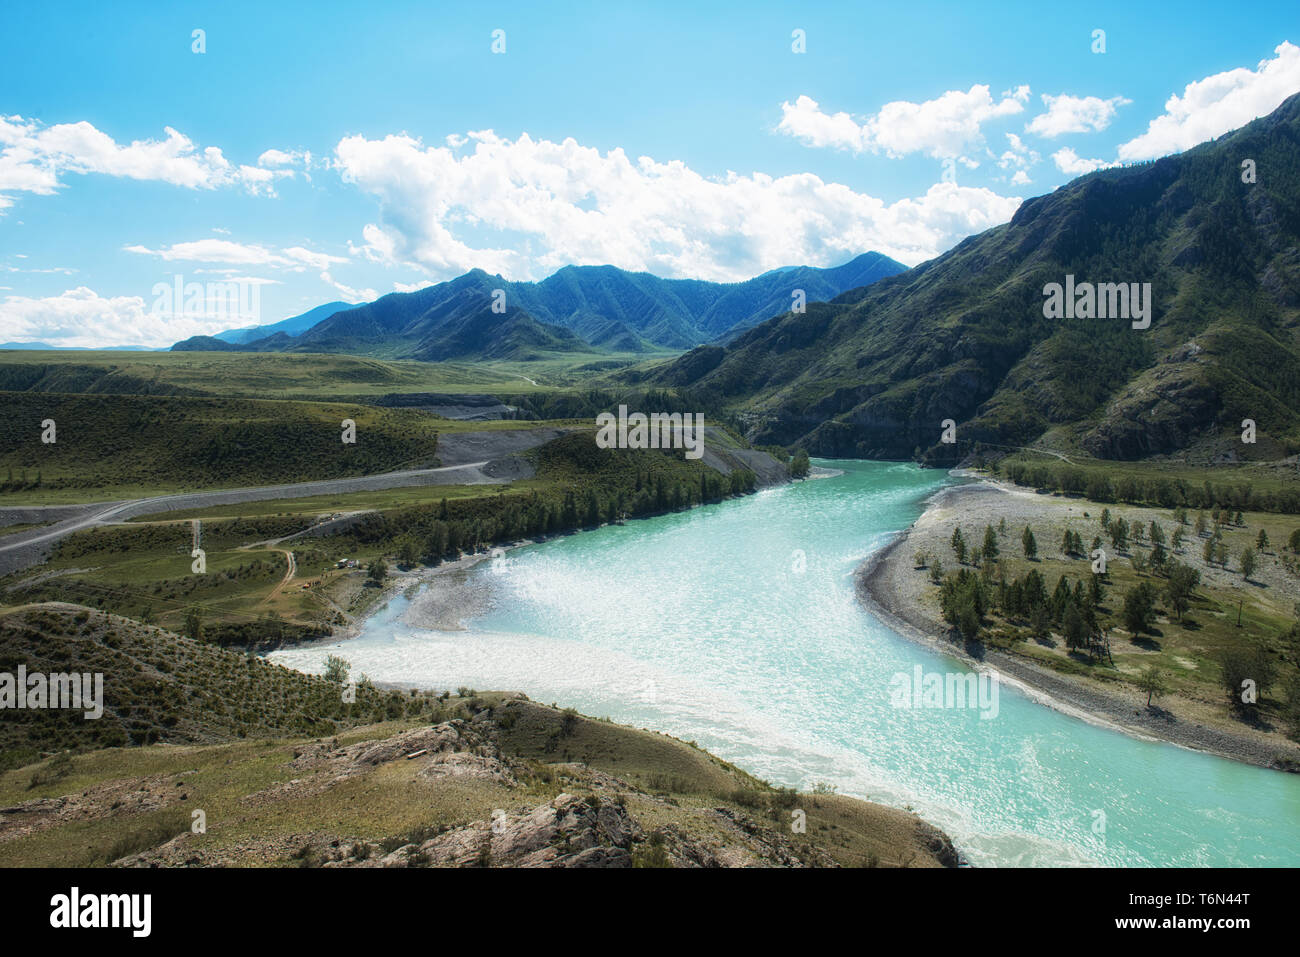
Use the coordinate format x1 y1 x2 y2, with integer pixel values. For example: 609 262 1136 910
858 479 1300 771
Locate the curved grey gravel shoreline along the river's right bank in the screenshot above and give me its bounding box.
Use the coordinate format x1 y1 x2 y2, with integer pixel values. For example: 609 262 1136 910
855 481 1294 770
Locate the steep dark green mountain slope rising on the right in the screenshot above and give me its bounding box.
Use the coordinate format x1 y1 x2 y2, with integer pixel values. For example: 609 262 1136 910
650 95 1300 460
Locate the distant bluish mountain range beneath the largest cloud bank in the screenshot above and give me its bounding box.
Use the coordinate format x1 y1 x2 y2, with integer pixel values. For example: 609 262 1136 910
173 252 905 358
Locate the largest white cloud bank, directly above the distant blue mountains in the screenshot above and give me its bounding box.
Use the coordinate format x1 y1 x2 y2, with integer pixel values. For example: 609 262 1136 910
334 130 1021 281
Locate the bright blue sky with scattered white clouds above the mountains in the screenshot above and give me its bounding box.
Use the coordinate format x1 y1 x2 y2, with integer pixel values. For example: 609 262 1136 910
0 0 1300 347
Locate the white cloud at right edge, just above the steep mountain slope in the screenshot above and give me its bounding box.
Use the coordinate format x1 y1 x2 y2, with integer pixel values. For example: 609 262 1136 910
1119 42 1300 161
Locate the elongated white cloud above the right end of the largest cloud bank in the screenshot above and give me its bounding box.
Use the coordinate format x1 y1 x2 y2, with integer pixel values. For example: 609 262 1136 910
776 85 1030 159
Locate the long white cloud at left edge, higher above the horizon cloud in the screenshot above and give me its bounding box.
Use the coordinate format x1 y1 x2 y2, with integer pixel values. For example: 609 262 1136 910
0 116 293 208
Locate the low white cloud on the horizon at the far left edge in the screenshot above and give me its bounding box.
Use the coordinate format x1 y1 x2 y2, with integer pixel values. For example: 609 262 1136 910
0 286 253 348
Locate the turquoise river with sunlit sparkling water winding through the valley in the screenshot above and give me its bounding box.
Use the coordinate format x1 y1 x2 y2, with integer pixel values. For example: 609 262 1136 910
273 462 1300 866
